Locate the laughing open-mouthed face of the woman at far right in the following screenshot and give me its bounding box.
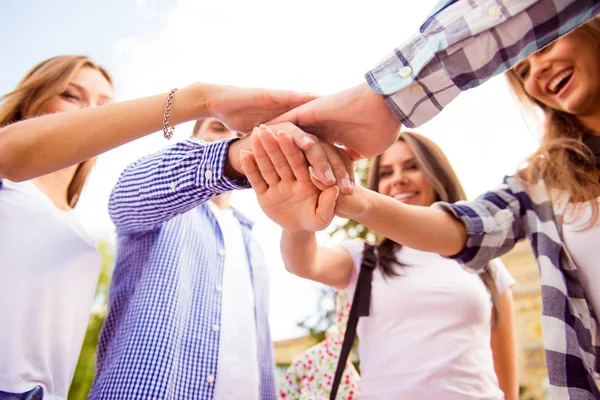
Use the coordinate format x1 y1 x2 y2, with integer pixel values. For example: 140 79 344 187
513 29 600 117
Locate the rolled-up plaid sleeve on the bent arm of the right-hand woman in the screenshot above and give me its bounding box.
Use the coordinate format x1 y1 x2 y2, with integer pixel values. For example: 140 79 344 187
434 177 529 272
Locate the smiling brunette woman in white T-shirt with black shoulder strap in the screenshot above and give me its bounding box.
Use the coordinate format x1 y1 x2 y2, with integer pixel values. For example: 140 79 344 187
242 128 518 400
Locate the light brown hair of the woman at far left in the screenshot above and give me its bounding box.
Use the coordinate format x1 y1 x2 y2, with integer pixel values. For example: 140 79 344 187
0 55 113 208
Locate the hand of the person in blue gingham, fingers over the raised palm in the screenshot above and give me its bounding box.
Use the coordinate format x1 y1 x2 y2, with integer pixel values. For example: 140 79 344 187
226 122 354 194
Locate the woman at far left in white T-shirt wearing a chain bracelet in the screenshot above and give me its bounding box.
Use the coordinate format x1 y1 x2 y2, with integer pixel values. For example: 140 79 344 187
0 56 352 399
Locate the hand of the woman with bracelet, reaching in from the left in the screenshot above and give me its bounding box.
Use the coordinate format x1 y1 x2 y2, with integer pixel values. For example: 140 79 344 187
202 84 316 133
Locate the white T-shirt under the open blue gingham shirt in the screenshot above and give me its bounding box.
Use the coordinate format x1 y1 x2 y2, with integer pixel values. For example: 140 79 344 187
209 202 259 400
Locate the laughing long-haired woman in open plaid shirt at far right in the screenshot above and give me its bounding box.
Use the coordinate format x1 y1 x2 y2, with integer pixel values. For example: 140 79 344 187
248 17 600 399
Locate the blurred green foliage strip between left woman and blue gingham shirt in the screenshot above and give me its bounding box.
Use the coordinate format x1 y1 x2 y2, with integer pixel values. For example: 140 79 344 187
68 240 115 400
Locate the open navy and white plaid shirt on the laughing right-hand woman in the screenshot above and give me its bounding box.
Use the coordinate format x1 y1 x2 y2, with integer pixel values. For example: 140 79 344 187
435 177 600 400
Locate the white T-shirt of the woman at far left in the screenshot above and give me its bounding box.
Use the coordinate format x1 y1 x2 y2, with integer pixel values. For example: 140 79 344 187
0 180 102 399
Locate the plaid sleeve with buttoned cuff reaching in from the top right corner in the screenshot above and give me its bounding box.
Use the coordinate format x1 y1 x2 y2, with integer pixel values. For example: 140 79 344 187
365 0 600 128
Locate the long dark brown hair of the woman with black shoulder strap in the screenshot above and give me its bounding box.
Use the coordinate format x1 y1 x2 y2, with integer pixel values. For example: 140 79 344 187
367 131 498 321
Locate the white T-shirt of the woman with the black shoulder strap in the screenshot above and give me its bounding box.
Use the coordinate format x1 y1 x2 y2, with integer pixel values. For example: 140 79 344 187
342 240 515 400
